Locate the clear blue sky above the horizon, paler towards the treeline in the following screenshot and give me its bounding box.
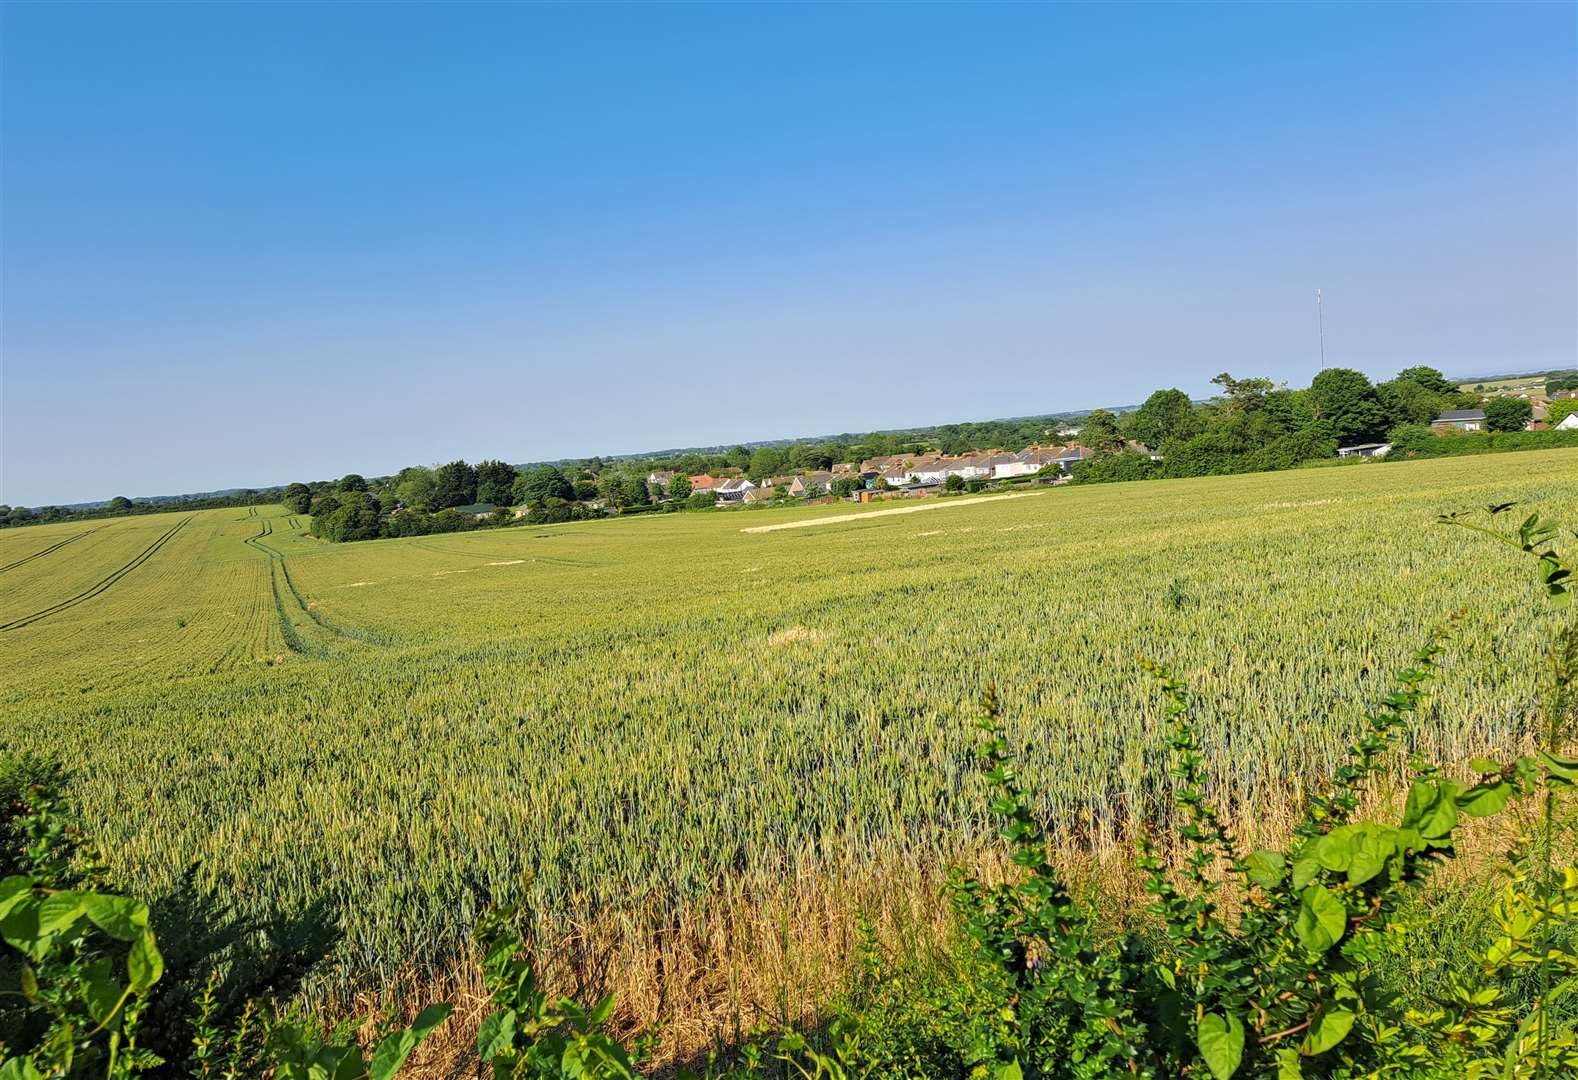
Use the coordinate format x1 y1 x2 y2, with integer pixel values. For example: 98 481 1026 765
0 3 1578 505
